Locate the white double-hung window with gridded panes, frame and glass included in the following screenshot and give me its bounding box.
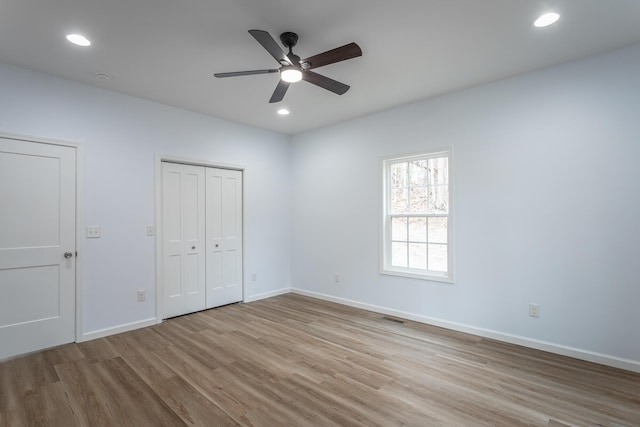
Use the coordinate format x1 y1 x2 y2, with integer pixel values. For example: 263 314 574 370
380 150 453 282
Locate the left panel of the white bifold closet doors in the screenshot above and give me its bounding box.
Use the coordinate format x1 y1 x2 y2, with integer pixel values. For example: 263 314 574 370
162 162 206 318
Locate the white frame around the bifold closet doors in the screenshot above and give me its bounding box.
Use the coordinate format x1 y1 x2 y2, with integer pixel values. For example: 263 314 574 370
154 154 247 324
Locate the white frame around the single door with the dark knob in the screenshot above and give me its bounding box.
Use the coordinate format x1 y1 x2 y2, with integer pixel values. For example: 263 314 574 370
0 132 84 342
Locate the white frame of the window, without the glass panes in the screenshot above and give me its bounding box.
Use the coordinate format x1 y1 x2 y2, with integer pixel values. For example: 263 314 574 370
380 148 454 284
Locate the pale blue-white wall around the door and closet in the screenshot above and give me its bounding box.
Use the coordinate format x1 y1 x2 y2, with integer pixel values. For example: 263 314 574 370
0 64 290 335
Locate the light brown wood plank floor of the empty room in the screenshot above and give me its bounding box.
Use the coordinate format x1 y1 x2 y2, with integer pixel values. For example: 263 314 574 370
0 294 640 427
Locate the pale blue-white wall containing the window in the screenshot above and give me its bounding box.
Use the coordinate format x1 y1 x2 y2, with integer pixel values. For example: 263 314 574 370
292 45 640 369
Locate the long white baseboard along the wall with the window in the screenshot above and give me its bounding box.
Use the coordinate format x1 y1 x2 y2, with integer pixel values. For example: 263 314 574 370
291 288 640 373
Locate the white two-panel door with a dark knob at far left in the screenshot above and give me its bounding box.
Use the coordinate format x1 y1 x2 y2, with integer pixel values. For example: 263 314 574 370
0 138 76 360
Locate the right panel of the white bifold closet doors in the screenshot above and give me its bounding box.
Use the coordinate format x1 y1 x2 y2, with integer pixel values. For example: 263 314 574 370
206 168 242 308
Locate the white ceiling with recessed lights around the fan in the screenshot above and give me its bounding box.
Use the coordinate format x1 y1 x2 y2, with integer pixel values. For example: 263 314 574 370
0 0 640 134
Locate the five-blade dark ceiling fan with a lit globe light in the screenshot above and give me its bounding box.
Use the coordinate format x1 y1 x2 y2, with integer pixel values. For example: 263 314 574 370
214 30 362 103
